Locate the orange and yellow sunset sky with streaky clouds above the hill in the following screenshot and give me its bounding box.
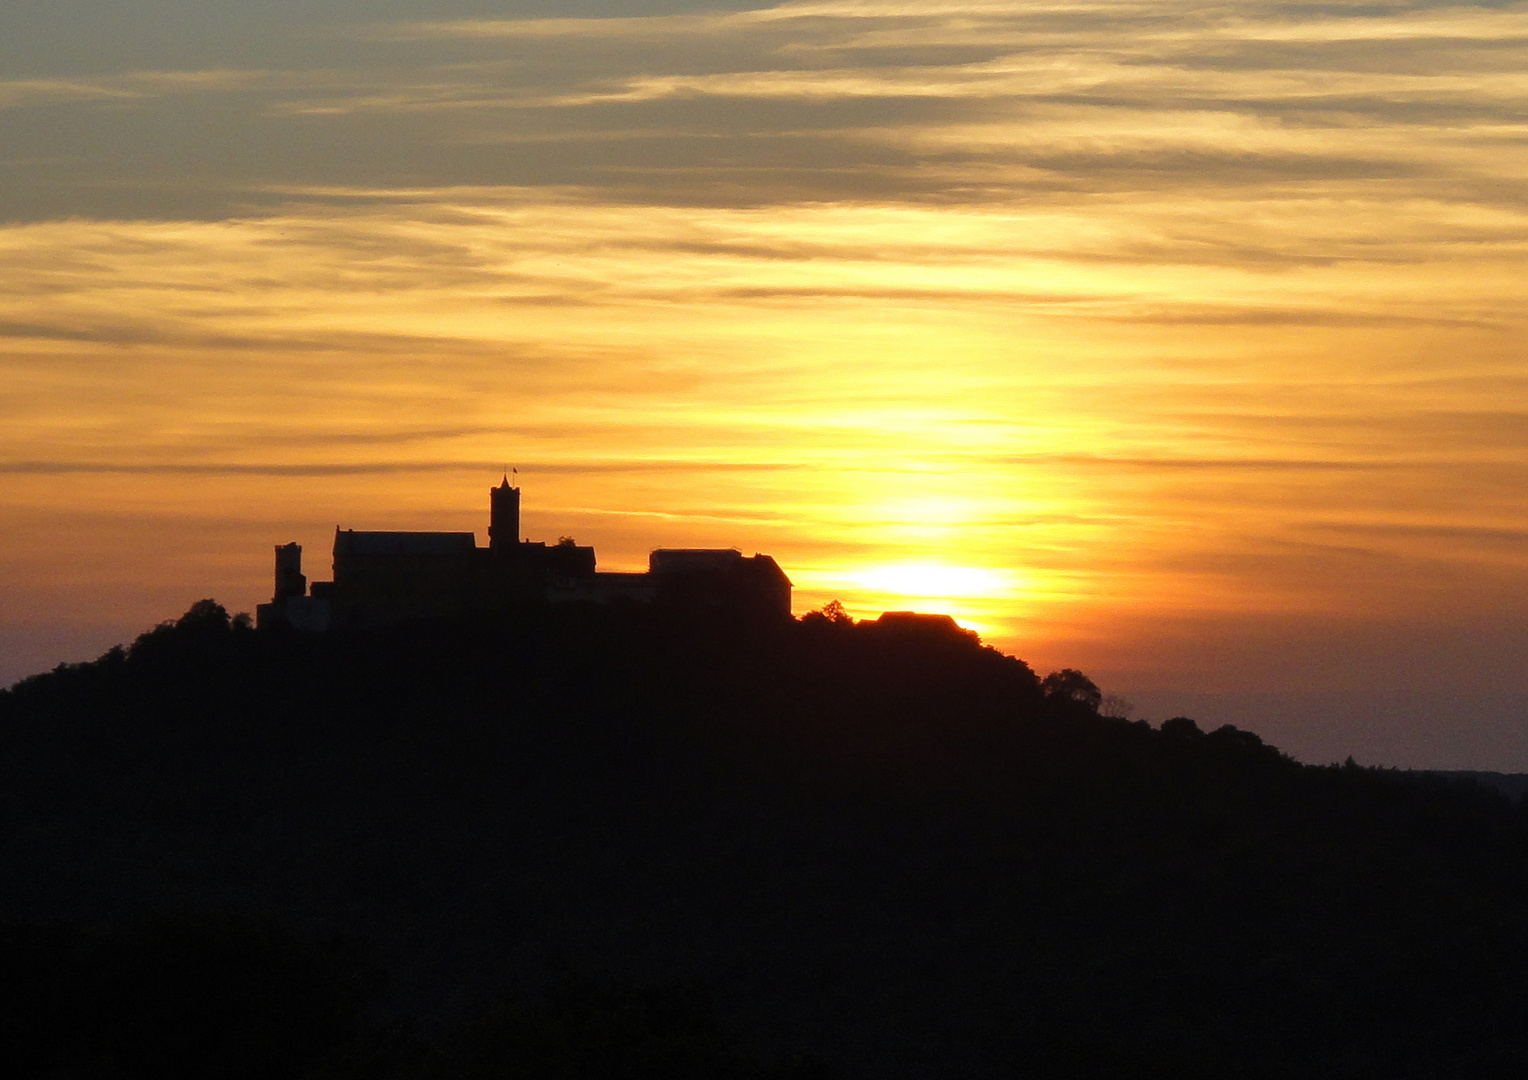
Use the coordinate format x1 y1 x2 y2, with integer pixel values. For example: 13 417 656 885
0 0 1528 771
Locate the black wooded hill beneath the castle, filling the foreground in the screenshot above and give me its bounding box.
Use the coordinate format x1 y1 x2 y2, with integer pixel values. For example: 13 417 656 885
0 605 1528 1078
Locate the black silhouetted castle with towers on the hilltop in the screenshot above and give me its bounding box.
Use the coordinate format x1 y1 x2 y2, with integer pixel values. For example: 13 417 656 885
255 477 792 631
